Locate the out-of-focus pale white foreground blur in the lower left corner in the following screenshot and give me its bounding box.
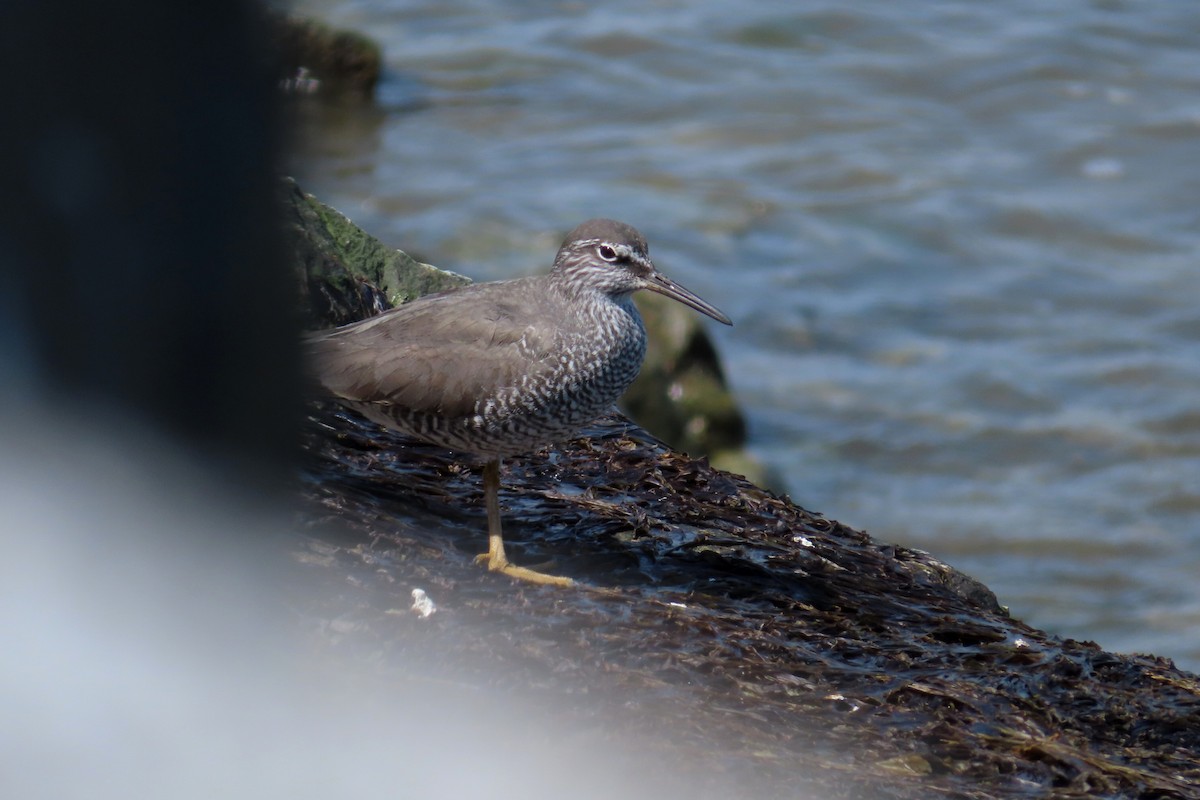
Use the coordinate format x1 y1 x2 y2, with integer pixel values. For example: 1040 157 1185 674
0 419 692 800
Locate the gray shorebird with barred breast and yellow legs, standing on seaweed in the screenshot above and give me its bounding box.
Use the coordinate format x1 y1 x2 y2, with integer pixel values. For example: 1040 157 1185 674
308 219 732 585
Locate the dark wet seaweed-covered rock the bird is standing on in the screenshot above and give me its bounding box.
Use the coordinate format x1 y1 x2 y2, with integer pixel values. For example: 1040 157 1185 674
293 184 1200 800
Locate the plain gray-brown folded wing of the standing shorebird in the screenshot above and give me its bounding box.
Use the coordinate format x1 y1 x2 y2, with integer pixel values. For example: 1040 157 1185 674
307 281 556 416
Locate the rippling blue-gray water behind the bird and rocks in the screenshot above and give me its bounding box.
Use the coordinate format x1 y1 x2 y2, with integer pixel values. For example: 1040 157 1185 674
293 0 1200 669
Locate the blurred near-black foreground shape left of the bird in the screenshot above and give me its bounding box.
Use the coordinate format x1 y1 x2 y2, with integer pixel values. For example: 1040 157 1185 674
0 0 298 489
